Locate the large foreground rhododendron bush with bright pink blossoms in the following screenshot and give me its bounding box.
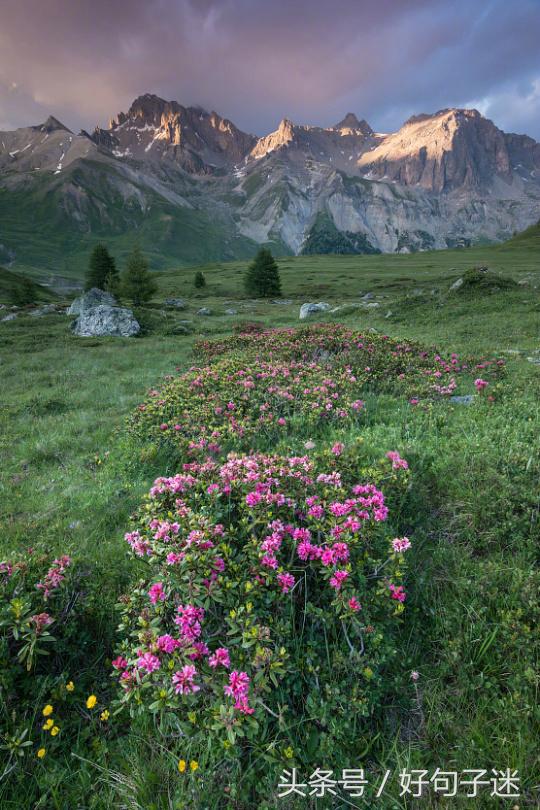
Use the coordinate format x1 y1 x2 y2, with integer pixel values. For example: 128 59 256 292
113 444 411 767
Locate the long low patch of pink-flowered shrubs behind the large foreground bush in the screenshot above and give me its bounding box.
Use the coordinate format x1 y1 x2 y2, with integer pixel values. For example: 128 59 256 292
128 325 504 457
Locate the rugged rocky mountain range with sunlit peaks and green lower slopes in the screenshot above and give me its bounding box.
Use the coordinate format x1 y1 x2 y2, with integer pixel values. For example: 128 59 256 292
0 94 540 276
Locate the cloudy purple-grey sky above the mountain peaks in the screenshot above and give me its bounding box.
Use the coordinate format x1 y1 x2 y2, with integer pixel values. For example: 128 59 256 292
0 0 540 140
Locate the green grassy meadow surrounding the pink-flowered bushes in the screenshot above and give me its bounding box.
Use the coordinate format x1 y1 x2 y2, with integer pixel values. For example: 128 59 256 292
0 249 540 810
